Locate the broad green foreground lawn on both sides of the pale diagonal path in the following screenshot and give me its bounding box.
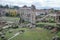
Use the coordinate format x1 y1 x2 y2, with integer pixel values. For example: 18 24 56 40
3 28 54 40
